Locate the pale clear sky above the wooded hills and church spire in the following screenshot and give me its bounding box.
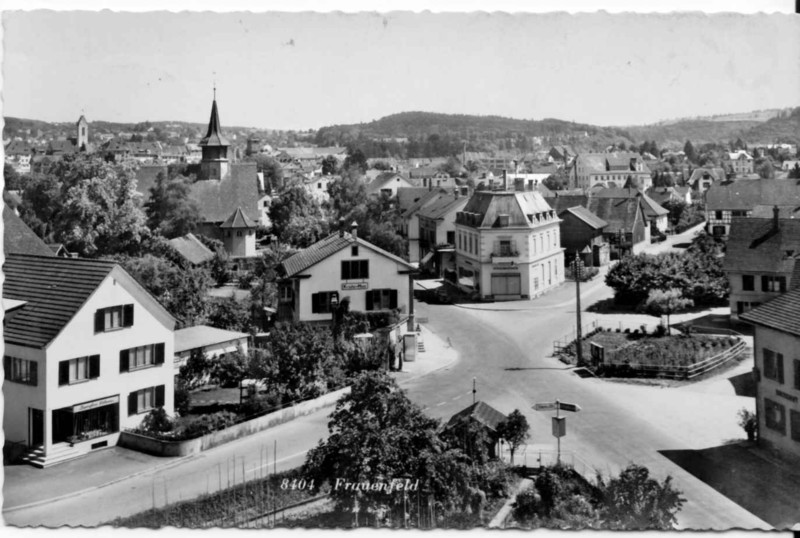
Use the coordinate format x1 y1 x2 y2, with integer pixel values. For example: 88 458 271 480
3 2 800 129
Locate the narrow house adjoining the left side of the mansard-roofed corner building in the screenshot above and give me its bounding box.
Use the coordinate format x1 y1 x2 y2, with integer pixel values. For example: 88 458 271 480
417 191 469 280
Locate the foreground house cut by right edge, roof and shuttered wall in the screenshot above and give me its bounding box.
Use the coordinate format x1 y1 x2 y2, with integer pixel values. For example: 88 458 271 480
741 283 800 458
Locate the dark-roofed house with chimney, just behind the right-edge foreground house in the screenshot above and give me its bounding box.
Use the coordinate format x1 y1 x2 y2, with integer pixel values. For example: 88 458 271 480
723 212 800 319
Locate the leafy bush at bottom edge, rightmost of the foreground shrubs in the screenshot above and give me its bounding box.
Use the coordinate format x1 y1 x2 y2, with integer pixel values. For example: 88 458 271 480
600 465 686 531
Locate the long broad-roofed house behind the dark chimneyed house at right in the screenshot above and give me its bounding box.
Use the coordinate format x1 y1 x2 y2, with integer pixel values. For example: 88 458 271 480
706 179 800 237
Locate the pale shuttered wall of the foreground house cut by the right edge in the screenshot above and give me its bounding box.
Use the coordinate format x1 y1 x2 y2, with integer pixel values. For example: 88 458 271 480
753 325 800 457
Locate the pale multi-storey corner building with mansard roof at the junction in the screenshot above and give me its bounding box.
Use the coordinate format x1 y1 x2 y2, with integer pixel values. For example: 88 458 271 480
455 191 564 300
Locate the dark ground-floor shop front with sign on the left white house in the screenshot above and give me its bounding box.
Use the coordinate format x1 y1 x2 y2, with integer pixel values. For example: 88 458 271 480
53 395 119 444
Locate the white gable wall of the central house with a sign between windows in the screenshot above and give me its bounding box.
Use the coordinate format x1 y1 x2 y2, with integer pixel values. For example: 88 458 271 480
295 245 409 322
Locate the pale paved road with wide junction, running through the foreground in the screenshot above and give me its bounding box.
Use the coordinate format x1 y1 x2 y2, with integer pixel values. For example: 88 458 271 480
4 222 768 529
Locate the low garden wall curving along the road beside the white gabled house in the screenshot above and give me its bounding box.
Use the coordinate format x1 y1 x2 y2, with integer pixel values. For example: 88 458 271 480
118 387 350 457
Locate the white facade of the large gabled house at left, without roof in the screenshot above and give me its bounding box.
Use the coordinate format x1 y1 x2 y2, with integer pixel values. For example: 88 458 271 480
3 268 174 454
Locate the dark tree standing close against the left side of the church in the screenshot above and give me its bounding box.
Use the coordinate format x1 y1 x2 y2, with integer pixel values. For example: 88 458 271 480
144 173 200 239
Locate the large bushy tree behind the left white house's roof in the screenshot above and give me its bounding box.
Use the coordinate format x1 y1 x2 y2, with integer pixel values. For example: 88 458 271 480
22 154 150 258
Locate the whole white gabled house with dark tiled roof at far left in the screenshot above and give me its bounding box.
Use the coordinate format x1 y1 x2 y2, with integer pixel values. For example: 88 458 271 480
3 254 175 466
